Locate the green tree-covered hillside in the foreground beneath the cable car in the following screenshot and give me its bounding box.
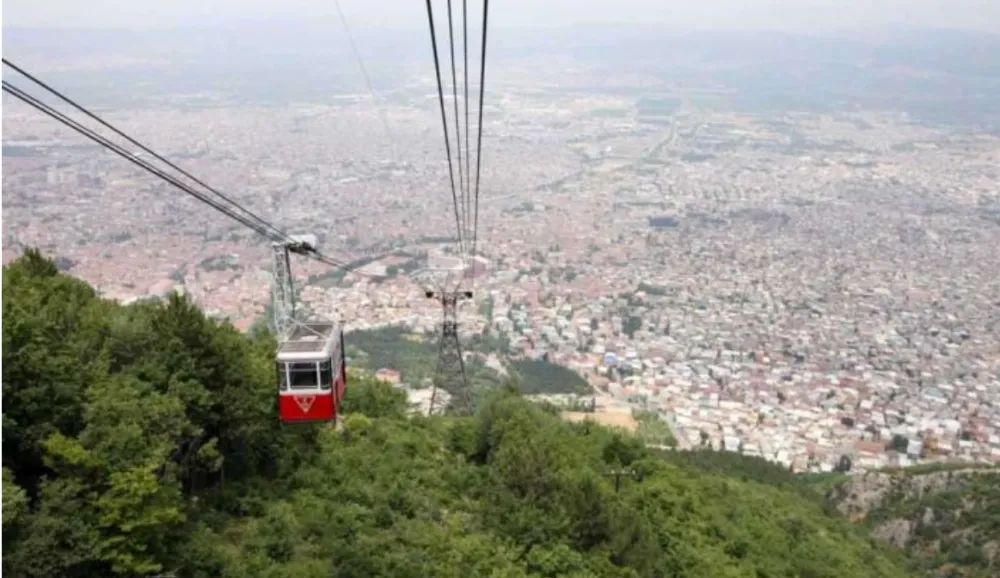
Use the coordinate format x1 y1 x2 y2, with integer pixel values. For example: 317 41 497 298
3 252 907 578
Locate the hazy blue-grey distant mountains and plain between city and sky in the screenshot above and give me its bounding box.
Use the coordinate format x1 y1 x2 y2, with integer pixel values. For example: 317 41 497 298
3 25 1000 131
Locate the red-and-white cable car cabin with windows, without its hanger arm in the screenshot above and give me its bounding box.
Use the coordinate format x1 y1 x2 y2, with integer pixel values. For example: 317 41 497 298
277 323 347 423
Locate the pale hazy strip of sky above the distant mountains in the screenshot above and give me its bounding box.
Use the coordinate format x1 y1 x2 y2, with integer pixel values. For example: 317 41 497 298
3 0 1000 32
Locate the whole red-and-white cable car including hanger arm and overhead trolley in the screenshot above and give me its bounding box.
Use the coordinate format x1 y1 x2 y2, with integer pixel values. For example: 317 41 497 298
271 235 347 423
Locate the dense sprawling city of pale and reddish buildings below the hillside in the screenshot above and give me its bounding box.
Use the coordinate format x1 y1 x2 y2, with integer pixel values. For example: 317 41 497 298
3 31 1000 471
